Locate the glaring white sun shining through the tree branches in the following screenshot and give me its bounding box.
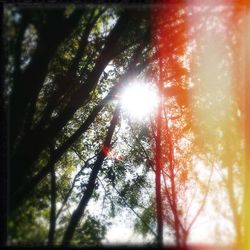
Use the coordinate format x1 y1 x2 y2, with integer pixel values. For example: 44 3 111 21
121 81 159 120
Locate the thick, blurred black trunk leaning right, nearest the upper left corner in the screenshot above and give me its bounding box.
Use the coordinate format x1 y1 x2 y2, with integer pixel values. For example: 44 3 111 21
10 11 83 148
